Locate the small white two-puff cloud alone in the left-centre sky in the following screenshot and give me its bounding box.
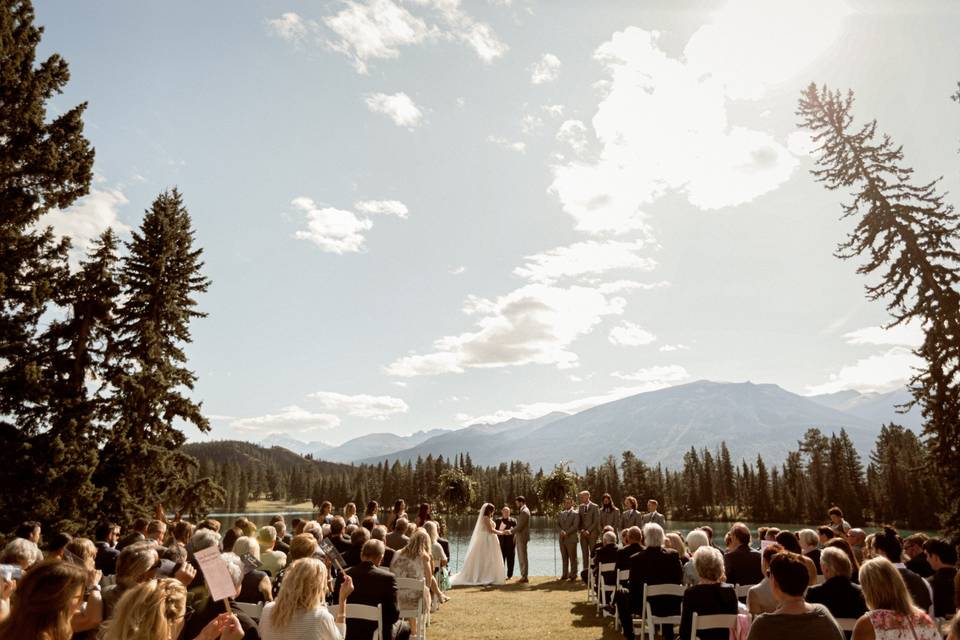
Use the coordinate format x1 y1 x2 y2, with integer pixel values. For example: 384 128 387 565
291 196 407 254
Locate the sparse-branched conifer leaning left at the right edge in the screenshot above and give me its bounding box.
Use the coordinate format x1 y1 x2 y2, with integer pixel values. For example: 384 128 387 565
798 84 960 533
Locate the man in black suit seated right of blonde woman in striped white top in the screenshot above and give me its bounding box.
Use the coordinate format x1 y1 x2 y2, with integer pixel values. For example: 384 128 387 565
347 540 410 640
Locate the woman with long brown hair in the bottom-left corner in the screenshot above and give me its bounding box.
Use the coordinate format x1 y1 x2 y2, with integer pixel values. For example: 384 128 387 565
0 564 88 640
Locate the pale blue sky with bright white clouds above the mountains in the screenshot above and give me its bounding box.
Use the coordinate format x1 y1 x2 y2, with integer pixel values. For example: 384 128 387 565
35 0 960 444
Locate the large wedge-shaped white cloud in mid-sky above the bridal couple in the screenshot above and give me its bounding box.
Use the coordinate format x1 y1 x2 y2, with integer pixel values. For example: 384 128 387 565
385 283 626 377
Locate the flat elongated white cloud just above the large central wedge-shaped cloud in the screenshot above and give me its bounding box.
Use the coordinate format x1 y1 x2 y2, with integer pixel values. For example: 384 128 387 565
513 240 656 283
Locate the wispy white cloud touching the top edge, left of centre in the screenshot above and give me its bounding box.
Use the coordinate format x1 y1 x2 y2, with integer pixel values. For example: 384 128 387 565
323 0 508 73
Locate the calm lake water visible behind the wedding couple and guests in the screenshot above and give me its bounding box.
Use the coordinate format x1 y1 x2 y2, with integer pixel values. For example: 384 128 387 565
211 512 928 576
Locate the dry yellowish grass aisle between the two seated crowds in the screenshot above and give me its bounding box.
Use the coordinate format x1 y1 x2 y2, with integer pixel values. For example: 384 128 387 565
427 578 623 640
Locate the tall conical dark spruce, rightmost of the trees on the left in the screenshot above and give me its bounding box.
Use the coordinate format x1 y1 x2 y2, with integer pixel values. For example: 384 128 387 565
97 189 210 520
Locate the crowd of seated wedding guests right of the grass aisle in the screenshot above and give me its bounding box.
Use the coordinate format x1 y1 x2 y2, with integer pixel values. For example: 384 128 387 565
584 498 960 640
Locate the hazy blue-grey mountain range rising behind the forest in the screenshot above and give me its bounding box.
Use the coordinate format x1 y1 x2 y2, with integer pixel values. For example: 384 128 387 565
261 380 920 471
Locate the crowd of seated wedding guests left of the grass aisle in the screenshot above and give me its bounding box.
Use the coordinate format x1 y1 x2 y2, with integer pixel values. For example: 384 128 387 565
0 500 449 640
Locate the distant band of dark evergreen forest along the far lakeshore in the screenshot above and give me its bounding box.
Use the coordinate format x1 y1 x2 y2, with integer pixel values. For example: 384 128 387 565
184 424 942 529
